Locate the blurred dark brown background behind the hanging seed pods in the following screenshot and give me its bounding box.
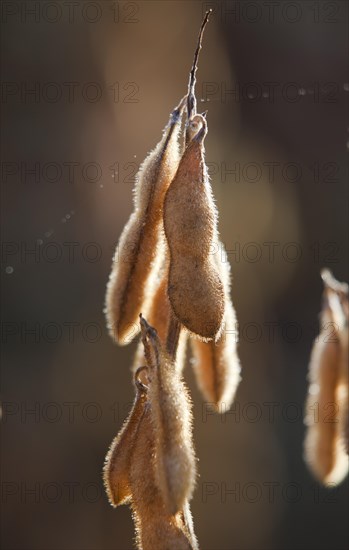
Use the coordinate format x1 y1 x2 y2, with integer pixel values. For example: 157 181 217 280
1 1 349 550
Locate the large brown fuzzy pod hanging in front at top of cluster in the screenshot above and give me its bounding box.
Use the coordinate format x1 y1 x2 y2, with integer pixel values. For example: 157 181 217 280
164 115 224 340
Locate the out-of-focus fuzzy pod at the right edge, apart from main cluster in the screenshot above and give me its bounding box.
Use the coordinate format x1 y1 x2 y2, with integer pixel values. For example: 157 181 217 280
304 272 349 484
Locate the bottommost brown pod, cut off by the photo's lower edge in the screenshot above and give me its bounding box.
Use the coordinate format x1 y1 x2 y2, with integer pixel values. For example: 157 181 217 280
130 404 197 550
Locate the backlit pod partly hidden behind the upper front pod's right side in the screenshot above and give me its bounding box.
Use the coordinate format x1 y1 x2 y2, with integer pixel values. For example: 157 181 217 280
191 248 241 413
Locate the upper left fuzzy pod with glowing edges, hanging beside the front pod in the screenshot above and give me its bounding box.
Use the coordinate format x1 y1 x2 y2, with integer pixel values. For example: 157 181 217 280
105 98 186 345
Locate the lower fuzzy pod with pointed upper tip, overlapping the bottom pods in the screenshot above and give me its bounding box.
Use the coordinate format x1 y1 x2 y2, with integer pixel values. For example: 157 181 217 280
141 318 196 514
